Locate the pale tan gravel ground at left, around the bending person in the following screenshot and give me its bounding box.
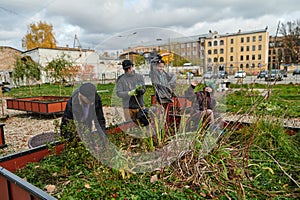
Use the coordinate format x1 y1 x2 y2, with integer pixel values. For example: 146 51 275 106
0 100 119 157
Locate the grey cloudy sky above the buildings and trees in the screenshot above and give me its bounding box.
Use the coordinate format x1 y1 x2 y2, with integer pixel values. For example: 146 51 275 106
0 0 300 50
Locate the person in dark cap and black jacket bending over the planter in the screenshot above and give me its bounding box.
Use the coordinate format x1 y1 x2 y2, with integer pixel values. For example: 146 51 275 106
60 83 106 140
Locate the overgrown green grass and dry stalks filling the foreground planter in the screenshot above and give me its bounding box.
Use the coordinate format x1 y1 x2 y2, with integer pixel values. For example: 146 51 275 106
17 116 300 199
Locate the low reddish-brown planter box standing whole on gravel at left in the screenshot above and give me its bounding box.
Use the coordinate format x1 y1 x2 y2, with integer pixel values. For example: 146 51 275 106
6 96 69 114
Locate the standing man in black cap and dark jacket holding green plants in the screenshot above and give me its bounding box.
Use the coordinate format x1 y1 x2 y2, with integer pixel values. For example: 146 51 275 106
116 60 146 121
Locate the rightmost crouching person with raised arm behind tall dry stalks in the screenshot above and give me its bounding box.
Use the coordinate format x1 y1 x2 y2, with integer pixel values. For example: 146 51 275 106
185 81 216 131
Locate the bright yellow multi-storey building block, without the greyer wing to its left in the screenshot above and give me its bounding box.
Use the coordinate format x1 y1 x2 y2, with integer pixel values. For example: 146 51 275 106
204 28 269 74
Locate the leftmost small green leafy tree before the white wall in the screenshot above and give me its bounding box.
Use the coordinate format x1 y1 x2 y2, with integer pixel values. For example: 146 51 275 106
13 56 42 86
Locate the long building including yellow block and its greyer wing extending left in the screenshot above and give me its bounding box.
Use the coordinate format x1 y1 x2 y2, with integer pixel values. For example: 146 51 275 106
126 28 270 74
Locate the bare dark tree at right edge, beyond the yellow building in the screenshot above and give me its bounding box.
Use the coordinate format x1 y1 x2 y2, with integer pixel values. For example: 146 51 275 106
279 20 300 64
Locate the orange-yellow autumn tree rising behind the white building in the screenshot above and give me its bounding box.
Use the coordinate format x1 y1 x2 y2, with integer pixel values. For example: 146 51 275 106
22 21 56 50
